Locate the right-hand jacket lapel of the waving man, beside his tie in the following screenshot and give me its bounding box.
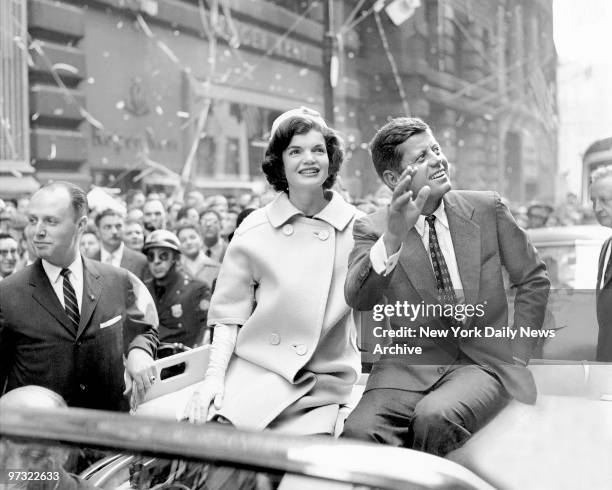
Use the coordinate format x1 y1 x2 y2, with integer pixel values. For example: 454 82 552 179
444 193 481 312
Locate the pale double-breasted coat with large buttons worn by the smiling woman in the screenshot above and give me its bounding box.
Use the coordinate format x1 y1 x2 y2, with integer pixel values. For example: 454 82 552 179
208 193 363 433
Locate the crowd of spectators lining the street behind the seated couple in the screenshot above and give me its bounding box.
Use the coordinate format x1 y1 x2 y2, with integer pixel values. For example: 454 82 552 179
0 187 596 288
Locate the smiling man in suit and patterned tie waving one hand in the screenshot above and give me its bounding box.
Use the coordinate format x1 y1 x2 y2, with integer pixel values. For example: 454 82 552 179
343 117 550 455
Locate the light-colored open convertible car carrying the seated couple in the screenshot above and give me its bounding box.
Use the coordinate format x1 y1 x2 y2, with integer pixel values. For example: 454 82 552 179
0 227 612 490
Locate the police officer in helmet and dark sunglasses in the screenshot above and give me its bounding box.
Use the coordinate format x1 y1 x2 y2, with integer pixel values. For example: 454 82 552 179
143 230 210 347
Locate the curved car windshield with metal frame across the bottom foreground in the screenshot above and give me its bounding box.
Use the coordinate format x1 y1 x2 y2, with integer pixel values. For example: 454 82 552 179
0 408 492 490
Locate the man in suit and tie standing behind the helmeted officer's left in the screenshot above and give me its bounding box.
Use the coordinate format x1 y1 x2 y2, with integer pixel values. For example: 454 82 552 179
94 209 148 281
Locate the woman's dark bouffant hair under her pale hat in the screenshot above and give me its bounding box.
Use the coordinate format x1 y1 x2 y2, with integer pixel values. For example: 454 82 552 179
261 117 344 192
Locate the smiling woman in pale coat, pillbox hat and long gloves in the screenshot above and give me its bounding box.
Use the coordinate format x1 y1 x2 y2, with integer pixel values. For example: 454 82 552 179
184 108 363 434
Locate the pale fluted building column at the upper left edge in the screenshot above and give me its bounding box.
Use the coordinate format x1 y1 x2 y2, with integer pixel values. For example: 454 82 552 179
0 0 30 162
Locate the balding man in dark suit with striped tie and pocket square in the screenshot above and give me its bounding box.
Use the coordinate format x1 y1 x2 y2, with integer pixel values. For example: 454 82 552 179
0 182 158 410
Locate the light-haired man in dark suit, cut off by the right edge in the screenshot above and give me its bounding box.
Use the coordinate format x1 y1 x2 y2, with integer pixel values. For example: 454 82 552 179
591 165 612 362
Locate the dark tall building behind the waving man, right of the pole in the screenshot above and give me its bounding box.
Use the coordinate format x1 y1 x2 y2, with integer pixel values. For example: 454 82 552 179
344 0 557 203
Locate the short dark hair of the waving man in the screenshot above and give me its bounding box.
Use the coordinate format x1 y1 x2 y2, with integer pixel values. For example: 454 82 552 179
370 117 431 178
